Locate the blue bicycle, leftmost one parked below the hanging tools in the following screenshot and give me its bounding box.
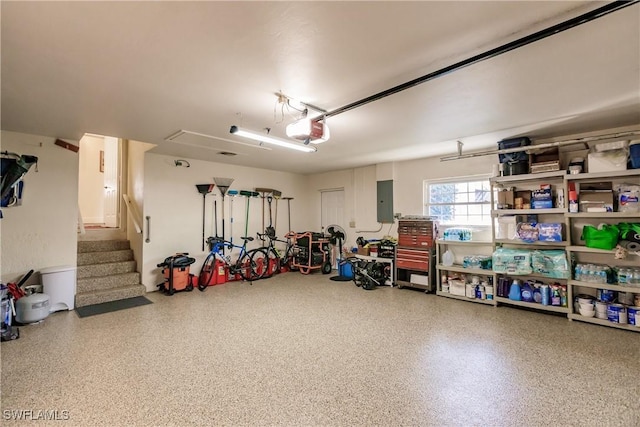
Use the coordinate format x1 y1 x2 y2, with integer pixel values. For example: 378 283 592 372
198 237 268 291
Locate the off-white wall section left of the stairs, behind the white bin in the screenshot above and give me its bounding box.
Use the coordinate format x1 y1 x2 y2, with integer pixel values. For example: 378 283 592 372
0 131 78 283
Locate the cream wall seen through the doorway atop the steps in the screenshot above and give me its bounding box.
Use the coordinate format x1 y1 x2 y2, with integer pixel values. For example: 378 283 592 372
78 135 104 223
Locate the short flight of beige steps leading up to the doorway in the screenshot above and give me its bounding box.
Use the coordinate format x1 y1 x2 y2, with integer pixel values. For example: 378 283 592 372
76 240 146 307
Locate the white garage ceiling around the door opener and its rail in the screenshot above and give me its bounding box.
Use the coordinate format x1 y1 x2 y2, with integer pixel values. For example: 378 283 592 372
1 1 640 173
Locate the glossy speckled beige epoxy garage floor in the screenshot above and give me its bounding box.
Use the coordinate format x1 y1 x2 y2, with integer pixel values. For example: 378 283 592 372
1 273 640 426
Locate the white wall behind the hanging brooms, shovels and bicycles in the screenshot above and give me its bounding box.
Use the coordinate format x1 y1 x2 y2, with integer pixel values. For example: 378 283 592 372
140 153 311 291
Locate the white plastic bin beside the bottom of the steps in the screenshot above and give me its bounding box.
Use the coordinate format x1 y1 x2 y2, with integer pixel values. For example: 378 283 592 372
40 265 76 313
